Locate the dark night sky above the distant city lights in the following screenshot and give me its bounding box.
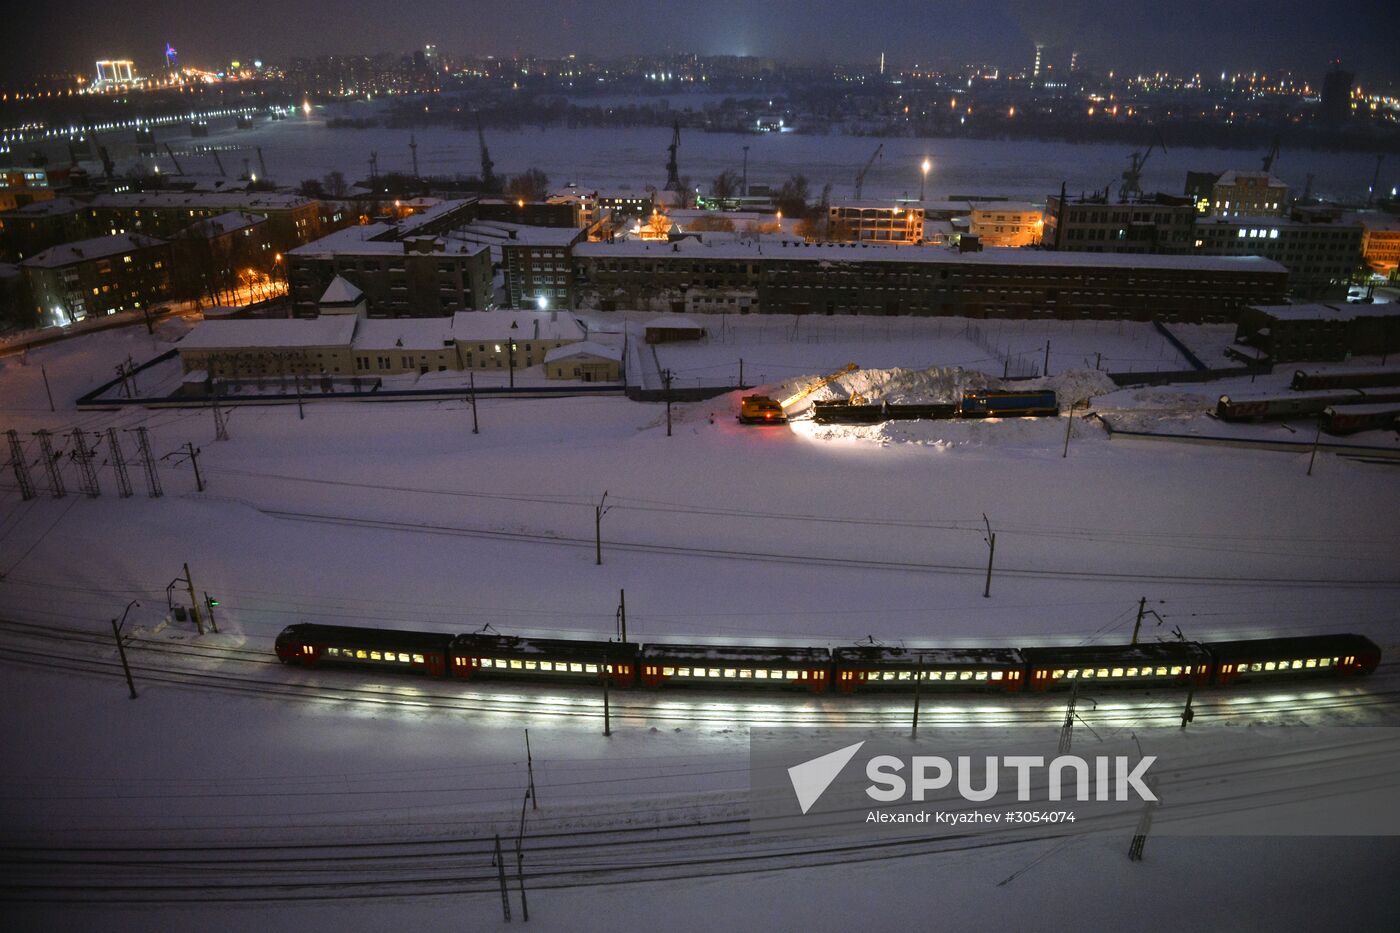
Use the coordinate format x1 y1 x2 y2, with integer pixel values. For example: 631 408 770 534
0 0 1400 85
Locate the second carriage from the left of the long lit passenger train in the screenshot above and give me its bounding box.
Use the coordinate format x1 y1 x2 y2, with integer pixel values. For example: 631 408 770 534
451 633 640 686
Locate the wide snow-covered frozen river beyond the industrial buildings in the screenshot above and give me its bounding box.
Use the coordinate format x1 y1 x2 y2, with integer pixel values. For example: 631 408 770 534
95 108 1400 202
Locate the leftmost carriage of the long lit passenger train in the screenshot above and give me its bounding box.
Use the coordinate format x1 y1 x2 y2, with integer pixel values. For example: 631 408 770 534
274 622 452 677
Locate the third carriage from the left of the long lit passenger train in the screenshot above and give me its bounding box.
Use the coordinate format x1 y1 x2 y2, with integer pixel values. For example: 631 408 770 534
641 644 832 693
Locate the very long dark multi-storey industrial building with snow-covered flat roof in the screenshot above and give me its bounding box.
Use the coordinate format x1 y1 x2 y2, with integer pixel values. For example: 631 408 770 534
574 238 1288 322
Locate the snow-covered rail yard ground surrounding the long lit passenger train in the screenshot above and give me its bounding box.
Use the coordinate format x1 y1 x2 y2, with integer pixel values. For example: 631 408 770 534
0 321 1400 930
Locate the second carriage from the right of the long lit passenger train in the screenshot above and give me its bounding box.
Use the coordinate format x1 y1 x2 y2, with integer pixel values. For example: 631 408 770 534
1021 642 1211 691
